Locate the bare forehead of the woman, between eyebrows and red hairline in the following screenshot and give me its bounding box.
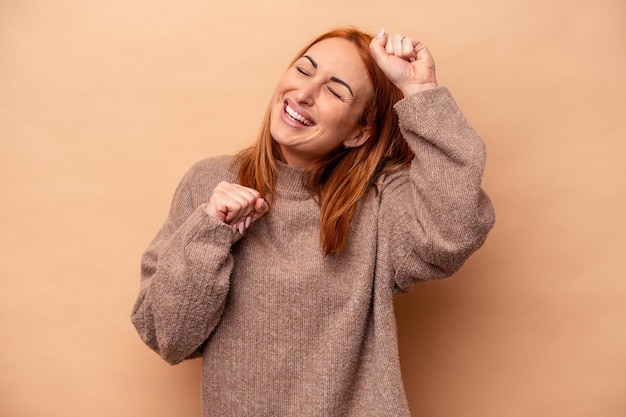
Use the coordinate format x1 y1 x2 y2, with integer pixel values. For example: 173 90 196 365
304 38 370 91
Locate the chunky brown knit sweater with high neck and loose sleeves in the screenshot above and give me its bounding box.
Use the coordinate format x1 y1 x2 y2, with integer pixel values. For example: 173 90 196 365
132 87 494 417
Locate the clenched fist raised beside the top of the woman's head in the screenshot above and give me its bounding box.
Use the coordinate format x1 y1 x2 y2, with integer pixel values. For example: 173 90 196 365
370 29 437 97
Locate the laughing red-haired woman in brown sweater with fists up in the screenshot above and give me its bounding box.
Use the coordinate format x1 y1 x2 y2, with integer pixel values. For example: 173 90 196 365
132 28 494 417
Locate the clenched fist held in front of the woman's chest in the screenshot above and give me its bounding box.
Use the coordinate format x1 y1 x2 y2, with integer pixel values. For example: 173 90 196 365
205 181 269 234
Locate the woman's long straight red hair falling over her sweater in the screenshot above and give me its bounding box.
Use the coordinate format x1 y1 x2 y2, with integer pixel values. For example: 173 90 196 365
233 27 414 255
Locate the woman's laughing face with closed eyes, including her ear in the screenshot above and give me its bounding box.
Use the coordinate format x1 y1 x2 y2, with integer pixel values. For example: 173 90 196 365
270 38 372 168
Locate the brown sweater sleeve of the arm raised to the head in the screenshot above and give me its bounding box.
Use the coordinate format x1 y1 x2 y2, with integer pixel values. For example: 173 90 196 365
380 87 495 292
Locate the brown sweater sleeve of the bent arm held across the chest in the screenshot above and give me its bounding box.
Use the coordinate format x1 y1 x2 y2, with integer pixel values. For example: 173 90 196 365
131 161 236 364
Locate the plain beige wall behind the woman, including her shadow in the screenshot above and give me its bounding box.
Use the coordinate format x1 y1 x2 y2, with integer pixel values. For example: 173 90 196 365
0 0 626 417
